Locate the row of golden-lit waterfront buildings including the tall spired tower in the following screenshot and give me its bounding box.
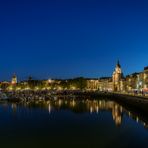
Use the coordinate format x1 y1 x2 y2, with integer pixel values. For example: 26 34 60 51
87 61 148 92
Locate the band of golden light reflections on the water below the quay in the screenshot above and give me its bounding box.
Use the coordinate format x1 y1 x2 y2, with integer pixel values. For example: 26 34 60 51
6 99 148 128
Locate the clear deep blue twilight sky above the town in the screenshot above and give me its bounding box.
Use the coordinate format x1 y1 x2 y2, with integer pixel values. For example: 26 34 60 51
0 0 148 80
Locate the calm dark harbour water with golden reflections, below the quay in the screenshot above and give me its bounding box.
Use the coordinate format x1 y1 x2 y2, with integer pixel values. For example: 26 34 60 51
0 99 148 148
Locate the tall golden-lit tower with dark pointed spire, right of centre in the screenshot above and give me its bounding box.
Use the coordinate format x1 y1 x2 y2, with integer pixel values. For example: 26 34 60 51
112 61 123 91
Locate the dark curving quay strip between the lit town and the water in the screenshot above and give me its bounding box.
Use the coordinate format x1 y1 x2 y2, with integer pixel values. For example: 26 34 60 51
0 91 148 113
